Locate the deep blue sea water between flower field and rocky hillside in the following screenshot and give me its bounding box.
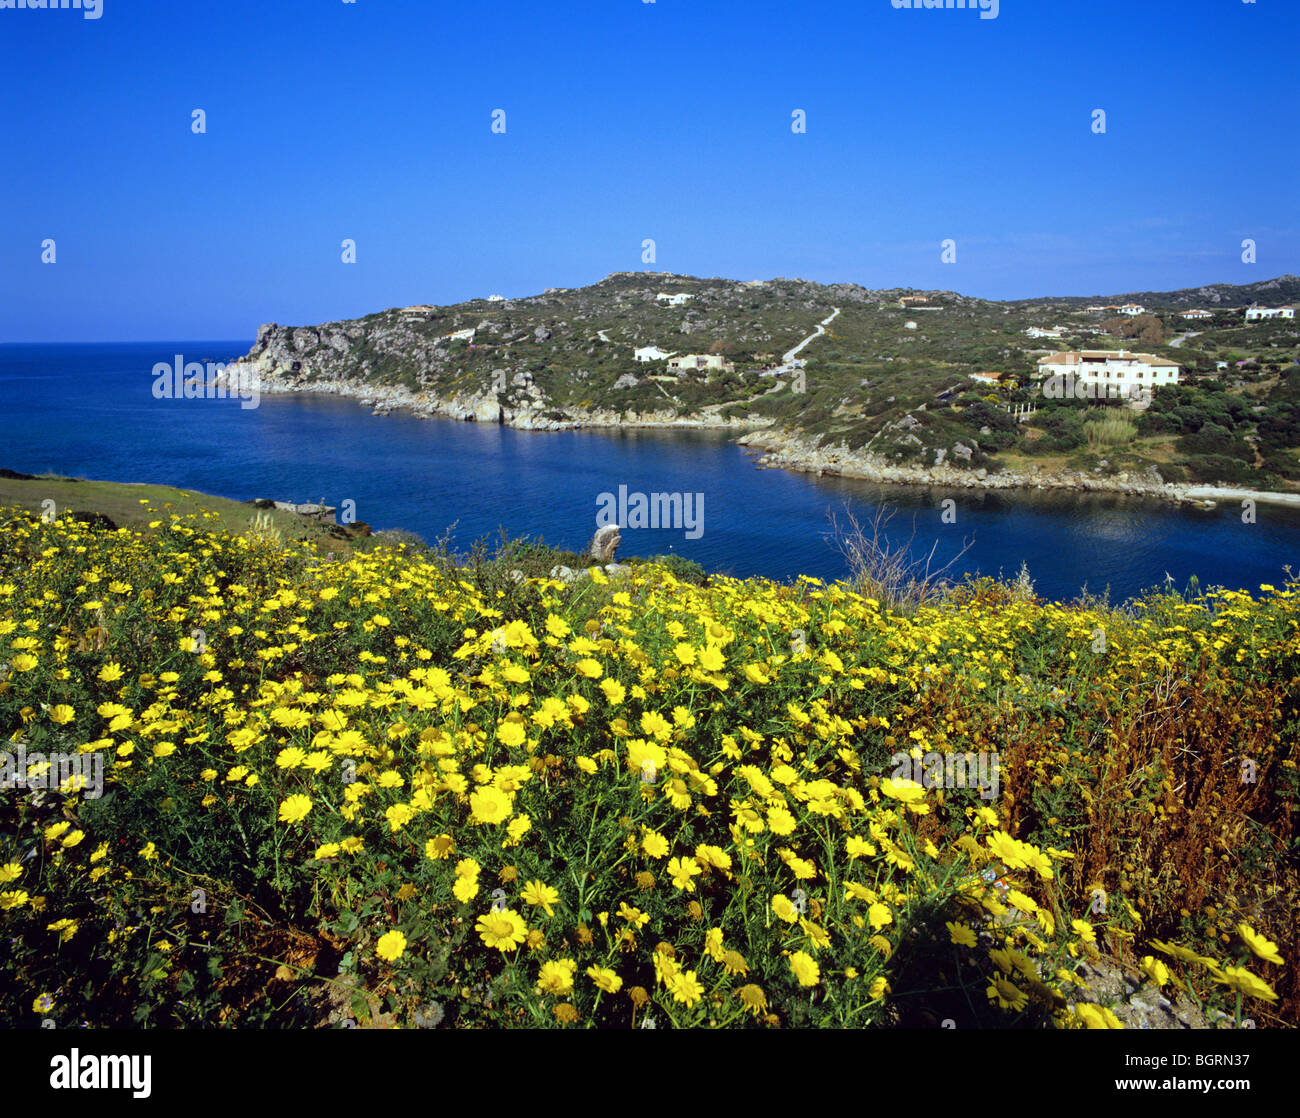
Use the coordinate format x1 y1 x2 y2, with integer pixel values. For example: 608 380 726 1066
0 341 1300 601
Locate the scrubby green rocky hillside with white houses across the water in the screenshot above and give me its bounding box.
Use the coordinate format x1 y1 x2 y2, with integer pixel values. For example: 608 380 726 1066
223 272 1300 490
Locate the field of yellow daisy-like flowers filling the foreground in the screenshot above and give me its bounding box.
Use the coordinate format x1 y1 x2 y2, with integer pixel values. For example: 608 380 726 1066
0 510 1300 1028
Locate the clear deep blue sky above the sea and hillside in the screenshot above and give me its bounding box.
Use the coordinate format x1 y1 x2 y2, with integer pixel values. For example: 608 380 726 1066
0 0 1300 341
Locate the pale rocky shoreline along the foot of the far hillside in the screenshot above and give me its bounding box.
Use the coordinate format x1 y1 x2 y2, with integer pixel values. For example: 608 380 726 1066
218 363 1300 510
